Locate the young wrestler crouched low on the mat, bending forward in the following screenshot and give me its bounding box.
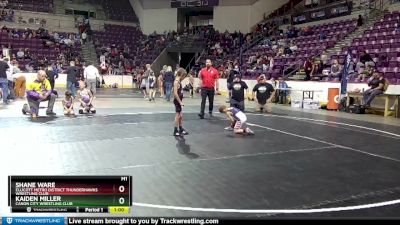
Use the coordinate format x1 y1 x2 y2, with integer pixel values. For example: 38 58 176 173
219 105 254 134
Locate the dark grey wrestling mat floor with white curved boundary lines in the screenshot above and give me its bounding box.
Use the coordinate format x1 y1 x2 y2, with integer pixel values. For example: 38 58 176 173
0 90 400 218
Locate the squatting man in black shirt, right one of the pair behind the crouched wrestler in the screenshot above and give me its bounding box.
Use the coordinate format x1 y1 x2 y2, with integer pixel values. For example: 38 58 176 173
253 75 275 113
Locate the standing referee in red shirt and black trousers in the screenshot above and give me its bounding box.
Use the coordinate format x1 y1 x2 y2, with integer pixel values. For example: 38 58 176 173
199 59 219 119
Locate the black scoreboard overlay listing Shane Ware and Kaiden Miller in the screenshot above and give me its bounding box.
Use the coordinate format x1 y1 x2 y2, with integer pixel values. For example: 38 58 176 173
8 176 132 214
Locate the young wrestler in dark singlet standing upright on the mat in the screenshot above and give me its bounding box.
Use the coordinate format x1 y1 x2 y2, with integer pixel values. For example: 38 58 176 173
174 68 189 136
